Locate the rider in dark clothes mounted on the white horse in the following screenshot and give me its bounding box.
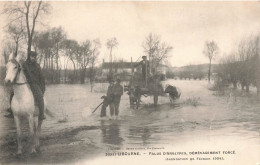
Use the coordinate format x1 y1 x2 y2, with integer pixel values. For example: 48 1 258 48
23 51 45 120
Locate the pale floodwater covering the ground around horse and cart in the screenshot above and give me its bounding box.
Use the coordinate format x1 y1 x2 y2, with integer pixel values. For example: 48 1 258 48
0 80 260 165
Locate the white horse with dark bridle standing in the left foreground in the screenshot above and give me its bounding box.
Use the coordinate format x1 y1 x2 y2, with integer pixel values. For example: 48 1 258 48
5 54 42 154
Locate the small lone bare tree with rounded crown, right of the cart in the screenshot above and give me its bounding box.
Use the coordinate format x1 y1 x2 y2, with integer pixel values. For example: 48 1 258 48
203 41 219 82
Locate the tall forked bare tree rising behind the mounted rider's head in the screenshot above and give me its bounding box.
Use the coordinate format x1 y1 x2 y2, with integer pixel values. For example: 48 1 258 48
3 1 50 56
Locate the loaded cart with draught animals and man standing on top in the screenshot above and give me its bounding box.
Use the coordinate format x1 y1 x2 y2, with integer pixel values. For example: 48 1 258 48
124 56 180 109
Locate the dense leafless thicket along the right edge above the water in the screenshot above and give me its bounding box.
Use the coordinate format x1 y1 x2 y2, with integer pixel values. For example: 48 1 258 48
216 35 260 93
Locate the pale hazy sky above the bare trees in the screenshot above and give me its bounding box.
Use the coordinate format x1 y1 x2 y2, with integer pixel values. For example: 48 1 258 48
0 1 260 66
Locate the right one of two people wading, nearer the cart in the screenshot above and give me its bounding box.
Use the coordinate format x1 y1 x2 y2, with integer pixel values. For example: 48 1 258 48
110 78 123 119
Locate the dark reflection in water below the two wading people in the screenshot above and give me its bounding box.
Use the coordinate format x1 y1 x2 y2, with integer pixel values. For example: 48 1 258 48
100 120 123 146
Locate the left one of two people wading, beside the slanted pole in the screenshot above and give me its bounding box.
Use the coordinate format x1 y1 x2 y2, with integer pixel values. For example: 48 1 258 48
100 78 114 117
